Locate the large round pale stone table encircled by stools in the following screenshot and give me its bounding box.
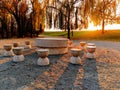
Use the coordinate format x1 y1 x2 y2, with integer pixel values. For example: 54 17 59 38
35 38 68 55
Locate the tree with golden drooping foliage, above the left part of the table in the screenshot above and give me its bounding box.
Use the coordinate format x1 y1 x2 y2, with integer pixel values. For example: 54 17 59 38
30 0 49 37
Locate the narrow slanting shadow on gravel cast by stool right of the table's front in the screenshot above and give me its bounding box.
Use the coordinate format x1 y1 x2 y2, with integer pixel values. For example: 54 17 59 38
54 63 82 90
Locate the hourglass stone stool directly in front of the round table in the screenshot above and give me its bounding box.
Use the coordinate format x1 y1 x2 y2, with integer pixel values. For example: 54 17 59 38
37 49 49 66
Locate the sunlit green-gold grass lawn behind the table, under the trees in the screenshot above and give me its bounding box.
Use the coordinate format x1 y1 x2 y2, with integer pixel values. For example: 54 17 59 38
42 30 120 41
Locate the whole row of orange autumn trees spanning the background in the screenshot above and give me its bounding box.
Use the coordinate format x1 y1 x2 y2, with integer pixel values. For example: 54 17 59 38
0 0 120 39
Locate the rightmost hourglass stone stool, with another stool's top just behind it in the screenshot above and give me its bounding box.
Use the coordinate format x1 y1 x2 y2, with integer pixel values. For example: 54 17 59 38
86 43 96 59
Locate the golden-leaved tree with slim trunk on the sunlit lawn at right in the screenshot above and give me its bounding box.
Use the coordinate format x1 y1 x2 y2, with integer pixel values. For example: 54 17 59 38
90 0 116 34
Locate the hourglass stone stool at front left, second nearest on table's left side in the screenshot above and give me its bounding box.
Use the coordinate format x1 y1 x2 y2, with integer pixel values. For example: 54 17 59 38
13 47 24 62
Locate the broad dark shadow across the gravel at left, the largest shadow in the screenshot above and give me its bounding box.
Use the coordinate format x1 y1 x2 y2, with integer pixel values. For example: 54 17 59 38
0 53 61 90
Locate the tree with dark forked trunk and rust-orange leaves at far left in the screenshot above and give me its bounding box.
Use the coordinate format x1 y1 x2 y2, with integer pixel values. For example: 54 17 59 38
1 0 28 37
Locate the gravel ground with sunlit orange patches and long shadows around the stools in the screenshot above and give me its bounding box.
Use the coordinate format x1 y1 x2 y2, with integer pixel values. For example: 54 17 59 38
0 39 120 90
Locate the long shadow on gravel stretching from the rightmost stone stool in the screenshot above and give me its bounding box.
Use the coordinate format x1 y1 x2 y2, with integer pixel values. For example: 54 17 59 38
83 59 101 90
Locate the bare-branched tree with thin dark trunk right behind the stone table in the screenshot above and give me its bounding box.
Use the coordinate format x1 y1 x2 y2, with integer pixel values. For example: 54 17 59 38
48 0 82 39
